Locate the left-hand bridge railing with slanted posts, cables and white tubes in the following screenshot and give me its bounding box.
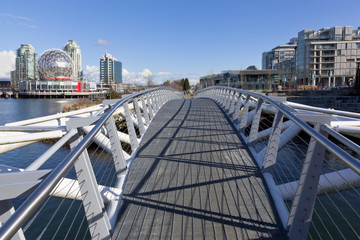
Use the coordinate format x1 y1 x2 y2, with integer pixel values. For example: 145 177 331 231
0 87 183 239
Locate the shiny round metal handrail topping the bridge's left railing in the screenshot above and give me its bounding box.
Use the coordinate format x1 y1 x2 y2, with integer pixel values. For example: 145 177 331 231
0 87 179 239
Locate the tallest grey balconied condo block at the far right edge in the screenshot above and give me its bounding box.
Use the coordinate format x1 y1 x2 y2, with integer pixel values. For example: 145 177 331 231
296 26 360 86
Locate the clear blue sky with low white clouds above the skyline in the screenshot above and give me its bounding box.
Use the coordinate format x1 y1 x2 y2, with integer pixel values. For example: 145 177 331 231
0 0 360 83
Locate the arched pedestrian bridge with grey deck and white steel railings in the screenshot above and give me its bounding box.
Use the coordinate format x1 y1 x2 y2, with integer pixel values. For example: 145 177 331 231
0 87 360 239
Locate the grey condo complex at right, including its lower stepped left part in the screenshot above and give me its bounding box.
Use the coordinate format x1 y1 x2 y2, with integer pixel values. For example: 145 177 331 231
262 26 360 87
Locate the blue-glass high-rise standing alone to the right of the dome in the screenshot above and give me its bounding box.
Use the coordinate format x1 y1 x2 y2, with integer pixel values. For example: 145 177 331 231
100 53 122 85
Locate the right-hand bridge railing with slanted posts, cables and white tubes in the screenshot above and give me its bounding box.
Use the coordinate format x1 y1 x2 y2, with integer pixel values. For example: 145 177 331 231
196 86 360 239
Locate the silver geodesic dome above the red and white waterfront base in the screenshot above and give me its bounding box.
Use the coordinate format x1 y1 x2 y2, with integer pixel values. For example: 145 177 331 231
38 49 73 80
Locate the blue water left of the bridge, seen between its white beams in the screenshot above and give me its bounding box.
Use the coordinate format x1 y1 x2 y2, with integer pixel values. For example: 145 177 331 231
0 98 91 239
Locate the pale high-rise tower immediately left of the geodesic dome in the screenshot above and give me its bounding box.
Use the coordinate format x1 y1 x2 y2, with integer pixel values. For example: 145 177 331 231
14 44 38 85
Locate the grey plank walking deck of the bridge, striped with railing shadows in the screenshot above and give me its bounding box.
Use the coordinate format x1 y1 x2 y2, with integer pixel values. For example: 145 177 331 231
113 99 286 239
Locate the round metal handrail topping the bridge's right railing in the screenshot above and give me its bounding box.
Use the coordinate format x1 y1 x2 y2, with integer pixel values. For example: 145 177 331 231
197 86 360 175
